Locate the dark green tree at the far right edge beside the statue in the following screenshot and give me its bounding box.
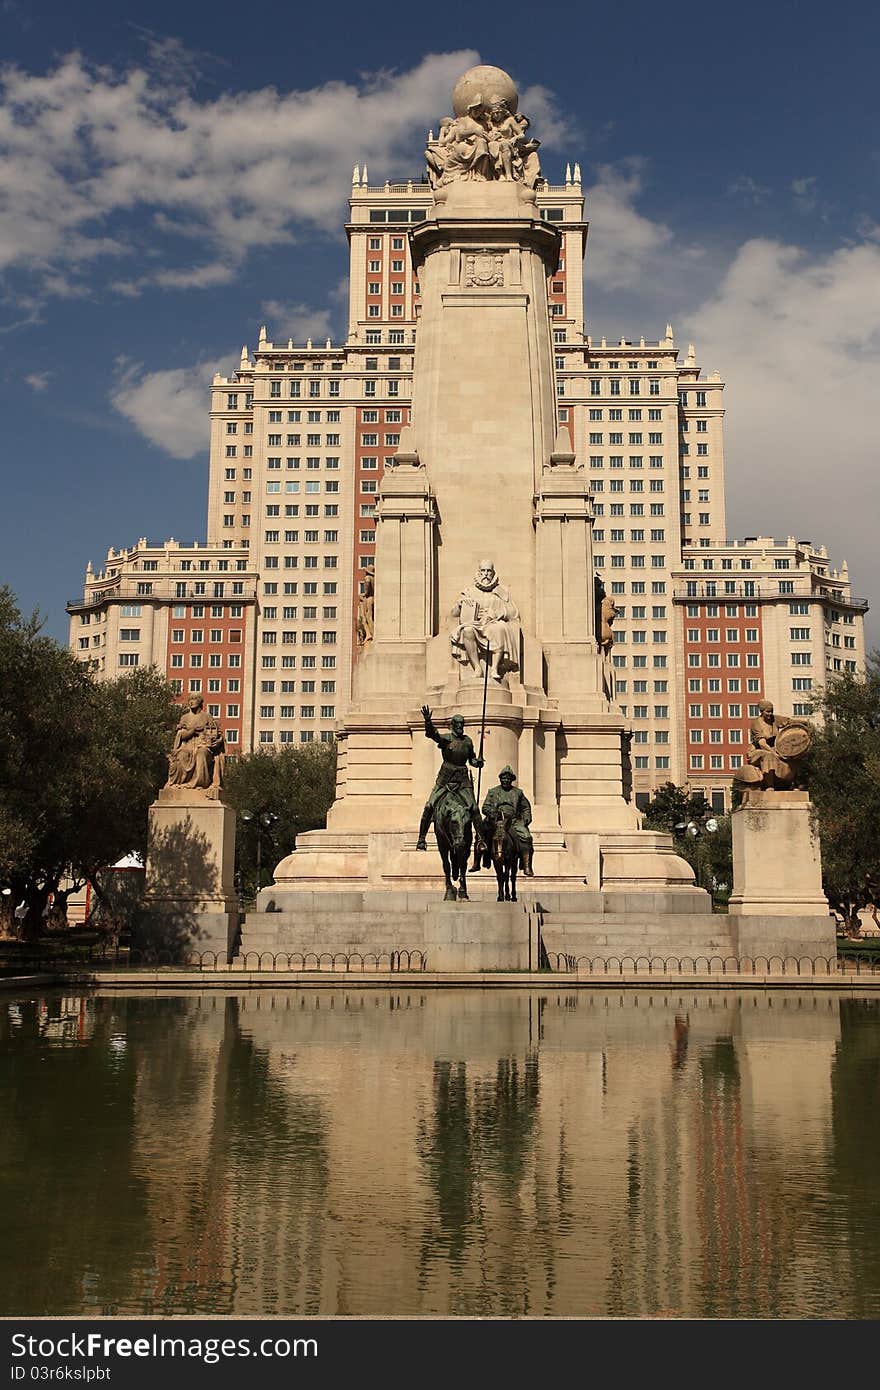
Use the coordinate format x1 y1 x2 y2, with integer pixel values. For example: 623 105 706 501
799 652 880 927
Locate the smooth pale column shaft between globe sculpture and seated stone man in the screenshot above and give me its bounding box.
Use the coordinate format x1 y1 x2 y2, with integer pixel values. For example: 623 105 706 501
410 182 559 634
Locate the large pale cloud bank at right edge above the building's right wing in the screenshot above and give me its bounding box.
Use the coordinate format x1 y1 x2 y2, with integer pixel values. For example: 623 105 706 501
684 239 880 631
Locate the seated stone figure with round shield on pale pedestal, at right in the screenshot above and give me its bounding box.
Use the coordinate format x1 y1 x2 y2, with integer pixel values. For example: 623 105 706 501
728 701 836 958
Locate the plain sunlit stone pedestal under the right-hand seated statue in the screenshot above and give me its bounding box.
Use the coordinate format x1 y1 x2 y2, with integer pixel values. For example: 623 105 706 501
730 791 836 958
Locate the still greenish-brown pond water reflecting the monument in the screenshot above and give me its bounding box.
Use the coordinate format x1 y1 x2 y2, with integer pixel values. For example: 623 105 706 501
0 986 880 1318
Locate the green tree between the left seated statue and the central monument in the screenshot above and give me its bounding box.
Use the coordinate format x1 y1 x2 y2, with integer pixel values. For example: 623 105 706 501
224 744 336 898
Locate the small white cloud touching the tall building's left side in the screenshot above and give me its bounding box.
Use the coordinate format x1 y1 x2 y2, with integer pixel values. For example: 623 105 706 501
110 353 238 459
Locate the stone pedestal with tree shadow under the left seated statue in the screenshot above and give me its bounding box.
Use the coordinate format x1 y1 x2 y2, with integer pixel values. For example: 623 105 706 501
145 787 239 959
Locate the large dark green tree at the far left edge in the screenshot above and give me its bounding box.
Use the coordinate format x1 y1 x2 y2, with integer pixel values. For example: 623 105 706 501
0 588 177 937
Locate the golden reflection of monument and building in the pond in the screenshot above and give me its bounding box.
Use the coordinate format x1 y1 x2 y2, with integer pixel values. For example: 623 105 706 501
118 986 851 1316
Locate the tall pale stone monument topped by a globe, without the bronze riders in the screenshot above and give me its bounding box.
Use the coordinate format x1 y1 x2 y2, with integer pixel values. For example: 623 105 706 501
247 67 709 967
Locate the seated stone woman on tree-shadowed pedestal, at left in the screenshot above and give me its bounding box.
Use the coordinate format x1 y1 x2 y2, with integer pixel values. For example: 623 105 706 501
146 695 239 958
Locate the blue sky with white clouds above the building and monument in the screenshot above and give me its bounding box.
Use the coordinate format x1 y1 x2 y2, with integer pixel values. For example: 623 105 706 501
0 0 880 637
